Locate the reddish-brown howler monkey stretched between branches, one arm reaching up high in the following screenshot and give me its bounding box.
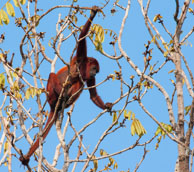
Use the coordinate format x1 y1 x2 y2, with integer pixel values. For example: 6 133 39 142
20 6 112 165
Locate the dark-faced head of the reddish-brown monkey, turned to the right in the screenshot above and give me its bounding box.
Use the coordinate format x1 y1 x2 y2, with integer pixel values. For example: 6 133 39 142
86 57 100 78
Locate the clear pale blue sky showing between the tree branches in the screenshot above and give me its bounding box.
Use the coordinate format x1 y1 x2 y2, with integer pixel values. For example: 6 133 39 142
0 0 194 172
